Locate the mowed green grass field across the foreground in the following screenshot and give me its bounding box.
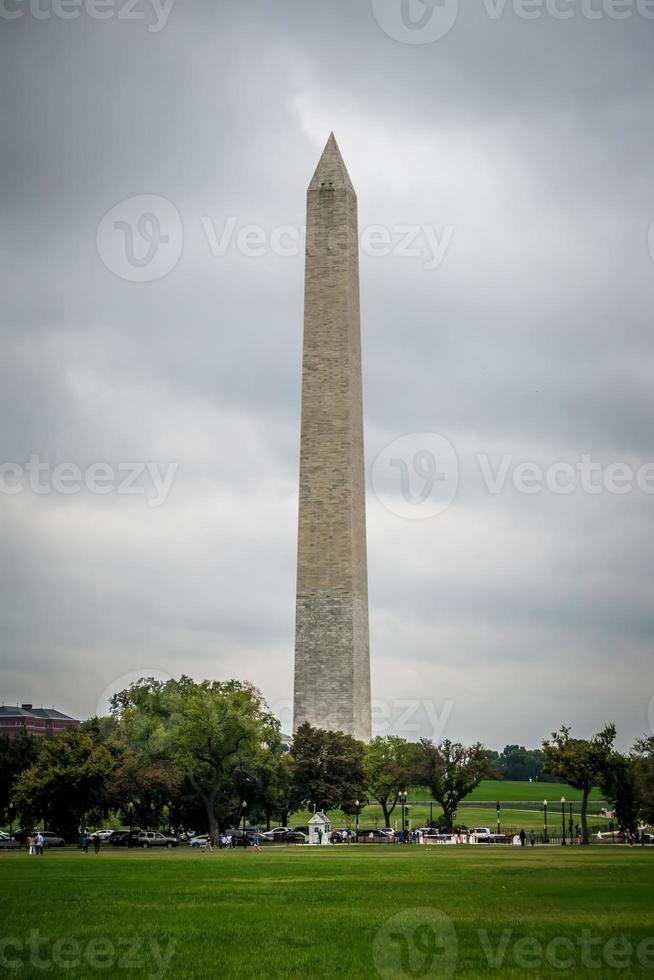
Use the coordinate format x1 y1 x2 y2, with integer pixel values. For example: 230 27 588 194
0 845 654 980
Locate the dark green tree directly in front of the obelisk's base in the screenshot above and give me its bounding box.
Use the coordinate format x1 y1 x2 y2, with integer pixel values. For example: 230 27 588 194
289 722 366 812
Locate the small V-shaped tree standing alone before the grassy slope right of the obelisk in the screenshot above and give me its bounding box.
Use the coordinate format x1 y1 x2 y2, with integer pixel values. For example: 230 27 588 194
416 738 497 833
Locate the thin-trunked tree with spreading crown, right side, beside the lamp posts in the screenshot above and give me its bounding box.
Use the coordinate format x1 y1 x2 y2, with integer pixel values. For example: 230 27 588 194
543 725 615 844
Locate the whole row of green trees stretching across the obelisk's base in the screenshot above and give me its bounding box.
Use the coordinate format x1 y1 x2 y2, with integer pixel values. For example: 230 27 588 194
0 677 654 842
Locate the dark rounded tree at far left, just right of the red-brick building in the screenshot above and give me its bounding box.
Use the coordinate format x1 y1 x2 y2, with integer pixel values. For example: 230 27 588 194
15 718 116 840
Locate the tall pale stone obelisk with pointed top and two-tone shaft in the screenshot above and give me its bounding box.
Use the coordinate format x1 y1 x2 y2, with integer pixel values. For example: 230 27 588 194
293 133 371 741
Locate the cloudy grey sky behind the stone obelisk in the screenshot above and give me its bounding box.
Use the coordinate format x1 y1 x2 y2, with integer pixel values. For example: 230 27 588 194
0 0 654 747
